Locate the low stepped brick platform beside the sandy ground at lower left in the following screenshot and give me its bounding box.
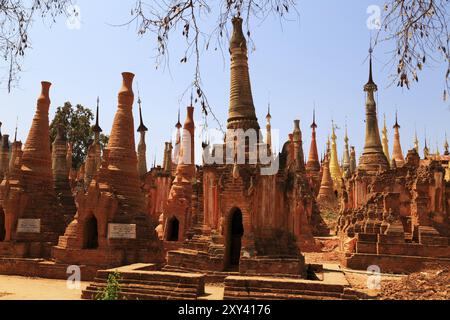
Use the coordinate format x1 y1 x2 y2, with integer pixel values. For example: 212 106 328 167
82 264 205 300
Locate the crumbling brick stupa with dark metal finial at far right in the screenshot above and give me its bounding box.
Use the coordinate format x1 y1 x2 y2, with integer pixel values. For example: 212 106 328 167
338 51 450 272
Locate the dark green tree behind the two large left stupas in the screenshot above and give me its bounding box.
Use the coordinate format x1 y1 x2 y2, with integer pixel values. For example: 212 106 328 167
50 102 109 169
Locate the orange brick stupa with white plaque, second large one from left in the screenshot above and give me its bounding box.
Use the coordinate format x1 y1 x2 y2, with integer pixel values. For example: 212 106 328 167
53 73 163 267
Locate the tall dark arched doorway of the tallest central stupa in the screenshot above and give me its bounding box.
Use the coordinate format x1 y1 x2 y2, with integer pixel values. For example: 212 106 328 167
226 209 244 270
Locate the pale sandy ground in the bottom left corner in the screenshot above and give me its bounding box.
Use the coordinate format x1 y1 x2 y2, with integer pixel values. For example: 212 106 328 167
0 275 88 300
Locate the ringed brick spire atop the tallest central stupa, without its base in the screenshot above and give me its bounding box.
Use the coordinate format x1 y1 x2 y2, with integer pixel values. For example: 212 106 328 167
227 17 260 134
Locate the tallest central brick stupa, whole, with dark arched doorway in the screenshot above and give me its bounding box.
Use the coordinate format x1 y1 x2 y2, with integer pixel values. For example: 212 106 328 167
166 18 326 275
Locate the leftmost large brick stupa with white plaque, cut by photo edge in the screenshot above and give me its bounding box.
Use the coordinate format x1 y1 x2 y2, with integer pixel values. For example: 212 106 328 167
0 82 64 258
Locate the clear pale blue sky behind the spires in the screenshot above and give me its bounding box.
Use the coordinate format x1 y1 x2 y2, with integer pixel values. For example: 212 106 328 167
0 0 450 164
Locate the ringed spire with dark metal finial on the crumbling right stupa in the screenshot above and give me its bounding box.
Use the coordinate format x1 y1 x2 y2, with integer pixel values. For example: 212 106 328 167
359 47 389 172
